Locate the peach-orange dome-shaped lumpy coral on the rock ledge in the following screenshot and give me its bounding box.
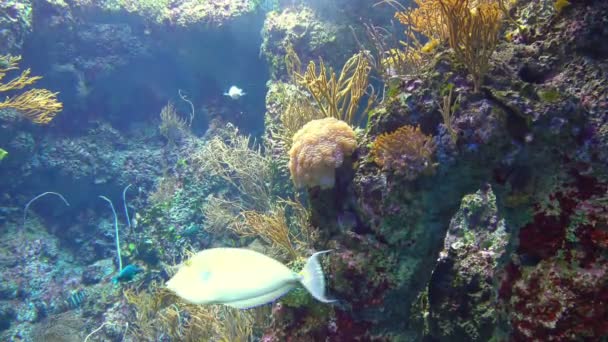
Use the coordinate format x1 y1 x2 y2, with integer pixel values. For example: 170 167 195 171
289 118 357 189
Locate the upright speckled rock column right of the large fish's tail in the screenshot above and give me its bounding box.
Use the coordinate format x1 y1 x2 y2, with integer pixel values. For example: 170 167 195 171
415 186 509 341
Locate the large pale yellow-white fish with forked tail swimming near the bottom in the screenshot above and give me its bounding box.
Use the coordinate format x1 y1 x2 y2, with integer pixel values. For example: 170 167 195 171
167 248 334 309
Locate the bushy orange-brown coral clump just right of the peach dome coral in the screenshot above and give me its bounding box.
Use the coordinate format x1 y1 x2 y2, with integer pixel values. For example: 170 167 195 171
371 126 435 179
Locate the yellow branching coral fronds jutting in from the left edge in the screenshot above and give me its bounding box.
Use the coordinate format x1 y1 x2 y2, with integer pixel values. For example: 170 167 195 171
0 55 63 124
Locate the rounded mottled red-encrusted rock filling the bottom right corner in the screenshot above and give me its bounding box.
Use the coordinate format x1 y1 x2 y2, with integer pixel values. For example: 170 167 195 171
508 258 608 341
